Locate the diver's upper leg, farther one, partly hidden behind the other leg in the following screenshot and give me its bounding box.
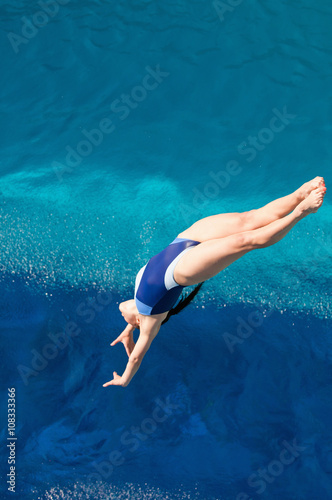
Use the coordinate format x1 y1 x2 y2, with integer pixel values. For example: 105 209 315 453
178 177 324 242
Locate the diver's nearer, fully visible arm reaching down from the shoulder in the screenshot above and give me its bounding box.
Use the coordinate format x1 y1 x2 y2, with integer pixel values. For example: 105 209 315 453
103 316 161 387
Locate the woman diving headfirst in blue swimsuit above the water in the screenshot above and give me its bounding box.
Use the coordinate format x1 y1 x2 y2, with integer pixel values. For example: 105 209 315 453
103 177 326 387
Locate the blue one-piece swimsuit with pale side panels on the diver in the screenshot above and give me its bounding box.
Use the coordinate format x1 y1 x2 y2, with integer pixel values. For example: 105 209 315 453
135 238 200 316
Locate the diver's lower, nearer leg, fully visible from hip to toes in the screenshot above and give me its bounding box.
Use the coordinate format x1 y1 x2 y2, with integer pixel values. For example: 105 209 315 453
174 187 326 286
